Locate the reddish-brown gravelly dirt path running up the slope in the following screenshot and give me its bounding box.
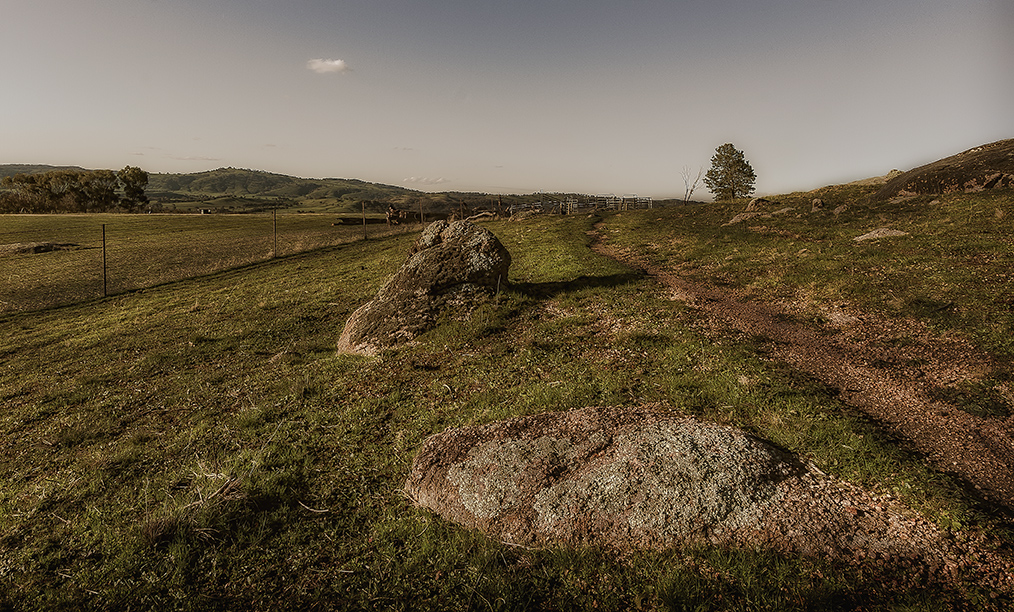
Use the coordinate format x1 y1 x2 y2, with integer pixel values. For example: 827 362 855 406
593 232 1014 510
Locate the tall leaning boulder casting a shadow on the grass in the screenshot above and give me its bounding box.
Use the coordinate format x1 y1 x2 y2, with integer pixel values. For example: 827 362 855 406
338 221 511 355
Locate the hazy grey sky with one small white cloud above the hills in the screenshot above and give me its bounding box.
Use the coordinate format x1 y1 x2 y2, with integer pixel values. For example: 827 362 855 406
0 0 1014 198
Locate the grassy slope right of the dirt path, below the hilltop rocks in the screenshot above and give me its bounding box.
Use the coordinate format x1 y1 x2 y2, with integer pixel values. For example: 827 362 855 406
607 185 1014 358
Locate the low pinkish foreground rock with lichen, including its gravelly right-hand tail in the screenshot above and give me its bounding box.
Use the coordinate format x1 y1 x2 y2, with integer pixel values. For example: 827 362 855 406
405 405 957 558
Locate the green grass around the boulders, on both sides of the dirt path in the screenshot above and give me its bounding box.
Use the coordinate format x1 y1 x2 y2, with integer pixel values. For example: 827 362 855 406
0 189 1014 610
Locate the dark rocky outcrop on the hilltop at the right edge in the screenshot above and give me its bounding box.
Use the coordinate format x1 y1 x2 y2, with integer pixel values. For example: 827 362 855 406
873 139 1014 201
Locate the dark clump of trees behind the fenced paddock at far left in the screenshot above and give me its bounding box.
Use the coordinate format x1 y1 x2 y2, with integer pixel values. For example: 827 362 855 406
0 166 148 213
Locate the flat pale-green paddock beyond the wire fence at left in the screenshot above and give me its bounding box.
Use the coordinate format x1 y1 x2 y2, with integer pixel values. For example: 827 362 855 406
0 214 405 312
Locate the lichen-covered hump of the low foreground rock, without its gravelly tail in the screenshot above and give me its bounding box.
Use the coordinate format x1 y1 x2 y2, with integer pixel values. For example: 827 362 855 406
406 408 802 547
